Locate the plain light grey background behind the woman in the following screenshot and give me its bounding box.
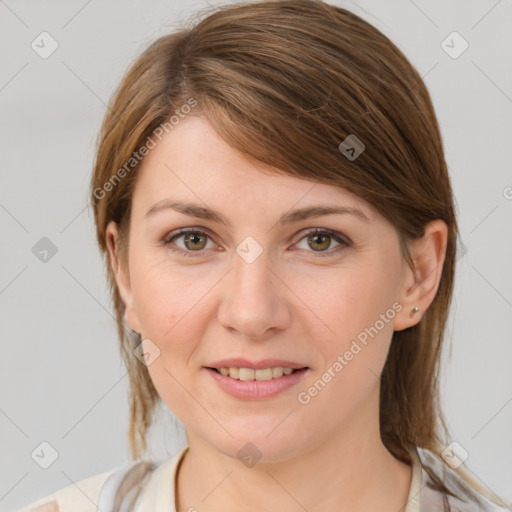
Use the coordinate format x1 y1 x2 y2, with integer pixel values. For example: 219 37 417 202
0 0 512 510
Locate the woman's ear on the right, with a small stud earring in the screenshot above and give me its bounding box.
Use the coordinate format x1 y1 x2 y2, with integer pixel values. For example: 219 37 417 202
393 219 448 331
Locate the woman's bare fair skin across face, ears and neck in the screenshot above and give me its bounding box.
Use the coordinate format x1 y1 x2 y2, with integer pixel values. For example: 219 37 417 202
106 117 447 512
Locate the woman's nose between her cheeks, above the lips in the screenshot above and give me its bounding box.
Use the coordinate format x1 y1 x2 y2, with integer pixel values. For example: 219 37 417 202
218 247 292 340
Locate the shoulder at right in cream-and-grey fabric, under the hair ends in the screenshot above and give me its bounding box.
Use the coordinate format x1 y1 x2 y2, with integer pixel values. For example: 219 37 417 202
417 447 510 512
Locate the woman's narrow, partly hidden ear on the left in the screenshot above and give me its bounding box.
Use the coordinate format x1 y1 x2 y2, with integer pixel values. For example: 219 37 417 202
105 221 141 333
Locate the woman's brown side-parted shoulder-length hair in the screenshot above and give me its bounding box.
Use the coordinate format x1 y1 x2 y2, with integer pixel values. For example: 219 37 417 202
90 0 500 506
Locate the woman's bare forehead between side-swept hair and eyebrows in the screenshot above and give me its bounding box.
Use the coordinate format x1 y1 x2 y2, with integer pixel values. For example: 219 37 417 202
133 116 378 223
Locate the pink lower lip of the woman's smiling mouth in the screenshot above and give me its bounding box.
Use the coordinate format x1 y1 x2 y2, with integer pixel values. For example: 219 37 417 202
205 368 309 400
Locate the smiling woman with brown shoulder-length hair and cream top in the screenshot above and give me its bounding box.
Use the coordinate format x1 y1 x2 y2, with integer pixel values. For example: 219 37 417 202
16 0 505 512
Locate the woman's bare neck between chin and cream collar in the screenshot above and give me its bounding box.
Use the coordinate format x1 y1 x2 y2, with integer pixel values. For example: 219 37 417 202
176 406 412 512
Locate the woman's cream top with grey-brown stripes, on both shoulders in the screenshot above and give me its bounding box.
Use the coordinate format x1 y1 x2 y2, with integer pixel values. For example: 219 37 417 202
17 446 510 512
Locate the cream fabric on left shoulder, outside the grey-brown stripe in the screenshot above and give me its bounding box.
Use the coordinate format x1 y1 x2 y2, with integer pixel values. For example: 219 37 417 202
15 463 122 512
